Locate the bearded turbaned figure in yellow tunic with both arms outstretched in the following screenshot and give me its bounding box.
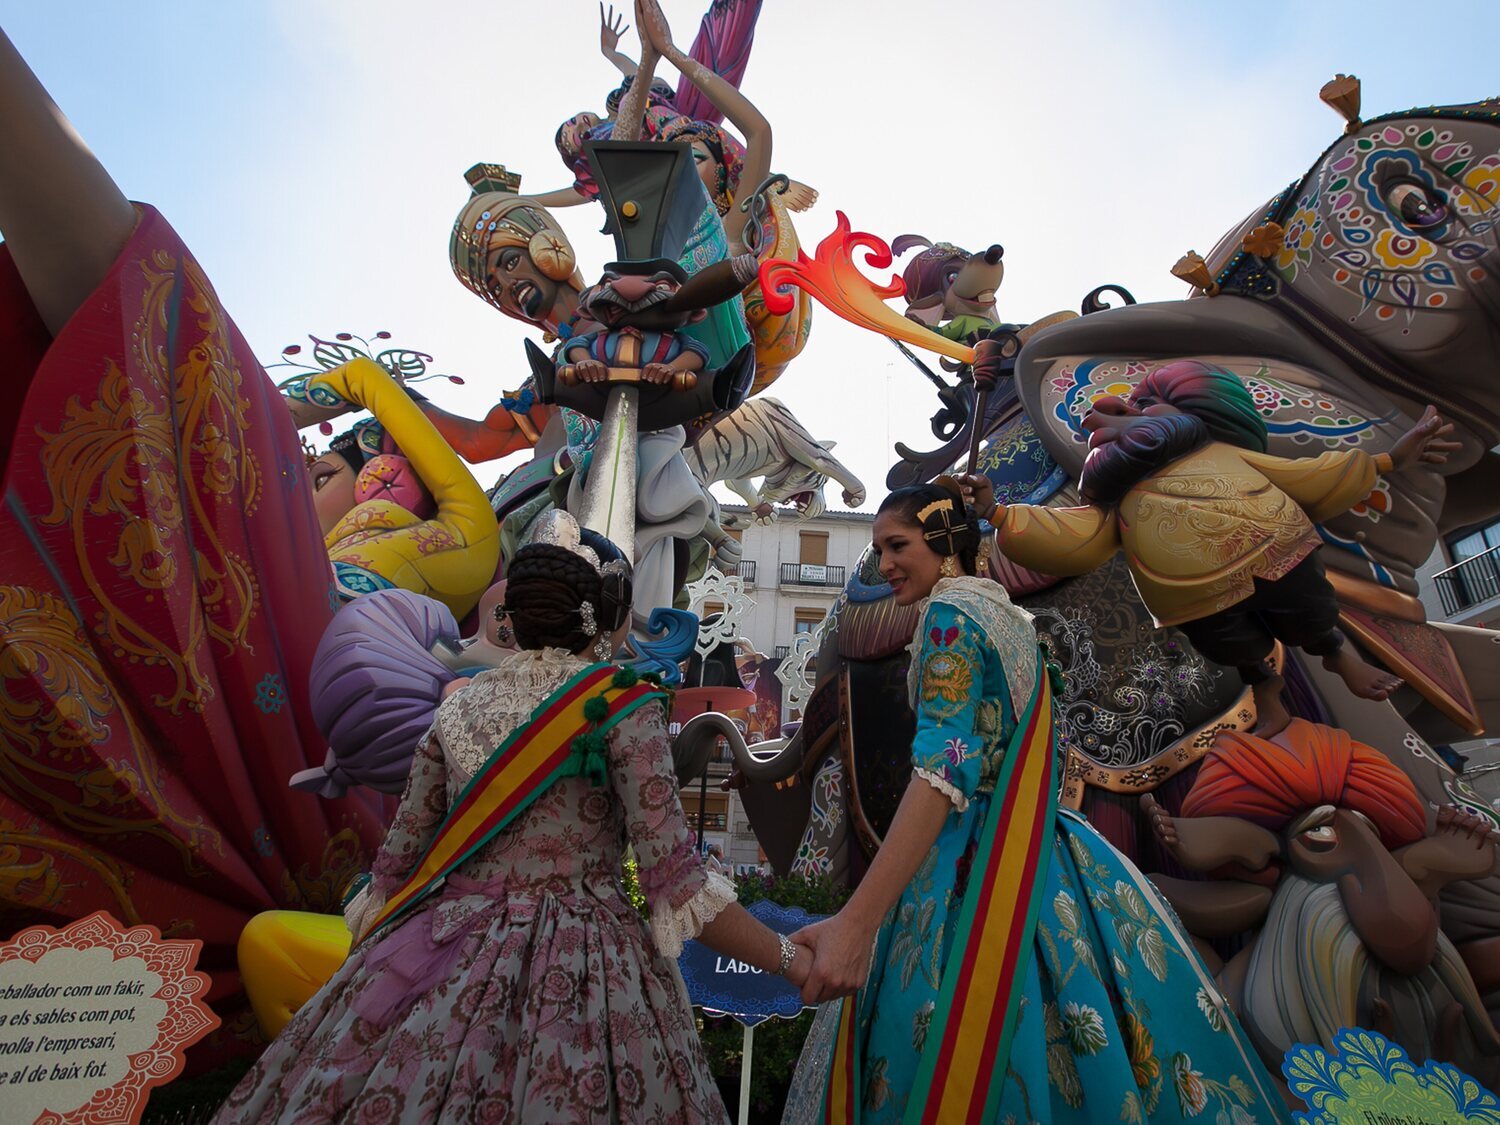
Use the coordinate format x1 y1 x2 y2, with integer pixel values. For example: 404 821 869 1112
965 357 1457 735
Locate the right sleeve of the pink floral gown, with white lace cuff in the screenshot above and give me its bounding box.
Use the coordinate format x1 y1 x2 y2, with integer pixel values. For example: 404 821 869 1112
609 705 735 959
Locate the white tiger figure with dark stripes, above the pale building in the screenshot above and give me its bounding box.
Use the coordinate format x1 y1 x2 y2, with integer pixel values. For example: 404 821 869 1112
683 396 866 524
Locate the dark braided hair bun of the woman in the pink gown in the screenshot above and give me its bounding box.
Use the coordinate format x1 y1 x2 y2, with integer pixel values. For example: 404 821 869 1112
506 543 608 653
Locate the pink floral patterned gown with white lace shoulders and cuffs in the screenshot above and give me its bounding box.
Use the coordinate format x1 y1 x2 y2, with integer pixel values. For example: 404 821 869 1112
216 650 734 1125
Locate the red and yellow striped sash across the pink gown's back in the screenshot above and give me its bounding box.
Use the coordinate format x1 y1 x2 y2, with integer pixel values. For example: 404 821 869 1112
357 665 662 941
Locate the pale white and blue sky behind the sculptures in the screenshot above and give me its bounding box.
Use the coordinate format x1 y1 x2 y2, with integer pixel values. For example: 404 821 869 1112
11 0 1500 509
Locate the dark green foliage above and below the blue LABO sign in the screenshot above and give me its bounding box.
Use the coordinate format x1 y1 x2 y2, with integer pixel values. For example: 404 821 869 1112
699 875 849 1122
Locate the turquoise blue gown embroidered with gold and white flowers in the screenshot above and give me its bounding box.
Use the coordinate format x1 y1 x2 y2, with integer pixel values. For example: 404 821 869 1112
783 578 1287 1125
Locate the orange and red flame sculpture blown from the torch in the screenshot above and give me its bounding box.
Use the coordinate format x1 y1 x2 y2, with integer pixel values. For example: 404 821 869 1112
761 212 974 363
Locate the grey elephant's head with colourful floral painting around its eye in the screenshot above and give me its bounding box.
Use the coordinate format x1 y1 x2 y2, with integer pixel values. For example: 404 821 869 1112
1209 93 1500 449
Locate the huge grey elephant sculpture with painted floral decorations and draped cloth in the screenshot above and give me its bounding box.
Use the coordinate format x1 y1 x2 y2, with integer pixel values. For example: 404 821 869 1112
740 83 1500 1068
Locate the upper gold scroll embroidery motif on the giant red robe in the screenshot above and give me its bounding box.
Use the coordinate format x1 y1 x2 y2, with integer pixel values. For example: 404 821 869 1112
39 251 261 714
